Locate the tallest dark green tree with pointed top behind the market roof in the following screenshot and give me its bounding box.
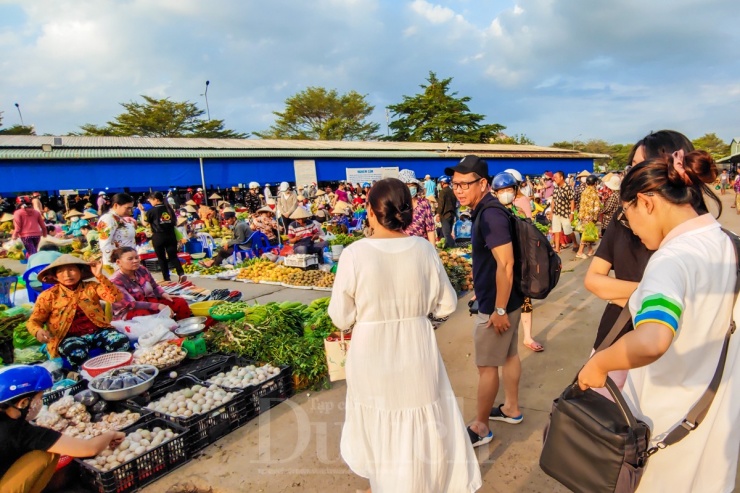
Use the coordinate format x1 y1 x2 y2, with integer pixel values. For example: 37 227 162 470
385 71 506 143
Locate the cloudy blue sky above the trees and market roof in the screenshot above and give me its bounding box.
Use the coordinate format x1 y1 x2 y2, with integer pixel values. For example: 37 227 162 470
0 0 740 145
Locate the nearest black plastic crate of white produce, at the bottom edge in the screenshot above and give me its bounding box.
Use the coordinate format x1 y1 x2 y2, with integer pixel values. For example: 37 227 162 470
75 417 190 493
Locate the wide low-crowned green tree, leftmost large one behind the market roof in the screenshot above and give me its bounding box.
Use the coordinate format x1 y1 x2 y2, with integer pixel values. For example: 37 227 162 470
80 95 249 139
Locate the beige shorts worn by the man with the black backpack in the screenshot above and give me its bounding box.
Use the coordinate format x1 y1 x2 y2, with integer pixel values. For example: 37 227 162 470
473 308 522 366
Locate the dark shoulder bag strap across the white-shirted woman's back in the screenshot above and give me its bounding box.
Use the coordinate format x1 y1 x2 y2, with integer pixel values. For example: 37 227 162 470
648 228 740 455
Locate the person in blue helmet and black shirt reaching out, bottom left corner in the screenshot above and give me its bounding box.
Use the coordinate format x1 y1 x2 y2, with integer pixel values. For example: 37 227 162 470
0 365 126 493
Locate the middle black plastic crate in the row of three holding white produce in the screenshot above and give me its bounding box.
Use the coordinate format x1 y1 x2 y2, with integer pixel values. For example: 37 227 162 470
128 375 251 454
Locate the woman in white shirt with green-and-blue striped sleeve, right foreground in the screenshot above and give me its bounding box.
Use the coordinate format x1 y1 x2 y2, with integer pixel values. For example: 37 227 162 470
578 151 740 493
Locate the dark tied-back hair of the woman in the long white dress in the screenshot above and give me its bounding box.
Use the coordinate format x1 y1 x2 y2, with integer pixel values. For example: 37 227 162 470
367 178 414 231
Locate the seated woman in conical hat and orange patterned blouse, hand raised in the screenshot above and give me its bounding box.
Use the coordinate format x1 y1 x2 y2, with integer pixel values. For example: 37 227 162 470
26 255 129 366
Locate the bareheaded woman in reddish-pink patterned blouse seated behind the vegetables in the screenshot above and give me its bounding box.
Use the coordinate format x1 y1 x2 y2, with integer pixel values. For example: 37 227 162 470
111 247 193 320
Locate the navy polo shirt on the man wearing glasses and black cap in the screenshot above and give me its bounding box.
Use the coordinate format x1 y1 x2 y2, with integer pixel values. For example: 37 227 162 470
471 193 524 315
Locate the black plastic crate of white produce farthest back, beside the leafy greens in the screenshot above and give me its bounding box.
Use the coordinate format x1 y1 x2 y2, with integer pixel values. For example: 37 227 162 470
193 356 294 418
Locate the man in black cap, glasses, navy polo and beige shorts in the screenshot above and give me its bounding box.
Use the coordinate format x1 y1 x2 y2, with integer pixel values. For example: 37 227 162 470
445 155 523 447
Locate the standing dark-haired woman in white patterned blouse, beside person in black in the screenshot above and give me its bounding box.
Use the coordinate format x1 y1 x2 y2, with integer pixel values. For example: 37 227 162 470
98 193 136 268
